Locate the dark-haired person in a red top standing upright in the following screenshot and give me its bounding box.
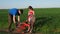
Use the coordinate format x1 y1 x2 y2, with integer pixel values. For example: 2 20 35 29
28 6 35 32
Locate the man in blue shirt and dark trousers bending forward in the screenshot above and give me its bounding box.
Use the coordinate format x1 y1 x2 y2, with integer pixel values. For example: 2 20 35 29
8 8 21 31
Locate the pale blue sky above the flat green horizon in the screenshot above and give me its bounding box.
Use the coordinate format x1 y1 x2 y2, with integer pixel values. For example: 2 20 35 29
0 0 60 9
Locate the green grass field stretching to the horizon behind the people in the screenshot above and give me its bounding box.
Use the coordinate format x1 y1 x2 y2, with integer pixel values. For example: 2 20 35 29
0 8 60 34
